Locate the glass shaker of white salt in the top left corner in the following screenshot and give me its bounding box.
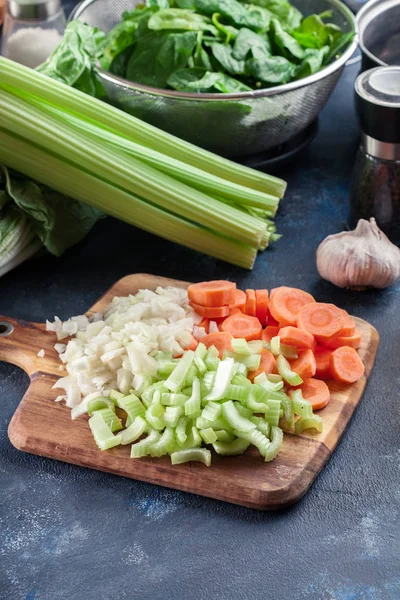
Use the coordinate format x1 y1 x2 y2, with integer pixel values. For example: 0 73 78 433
1 0 66 69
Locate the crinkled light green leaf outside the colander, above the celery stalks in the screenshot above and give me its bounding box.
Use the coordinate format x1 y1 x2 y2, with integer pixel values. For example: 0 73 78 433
36 21 106 99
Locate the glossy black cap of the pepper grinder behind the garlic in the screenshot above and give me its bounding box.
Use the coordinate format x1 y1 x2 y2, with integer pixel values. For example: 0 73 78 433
354 67 400 144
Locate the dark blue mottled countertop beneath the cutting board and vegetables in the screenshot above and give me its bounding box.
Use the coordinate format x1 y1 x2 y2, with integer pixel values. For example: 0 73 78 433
0 17 400 600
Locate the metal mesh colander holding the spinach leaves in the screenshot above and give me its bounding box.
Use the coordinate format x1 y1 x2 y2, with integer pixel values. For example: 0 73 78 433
70 0 357 157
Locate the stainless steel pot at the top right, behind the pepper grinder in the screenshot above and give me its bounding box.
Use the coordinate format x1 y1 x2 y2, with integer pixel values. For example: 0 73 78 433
356 0 400 71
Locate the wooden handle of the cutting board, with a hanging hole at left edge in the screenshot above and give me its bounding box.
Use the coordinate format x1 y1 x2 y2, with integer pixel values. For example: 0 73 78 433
0 315 48 375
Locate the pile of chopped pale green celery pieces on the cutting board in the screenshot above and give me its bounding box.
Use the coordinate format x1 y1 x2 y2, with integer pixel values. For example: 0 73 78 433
85 340 322 466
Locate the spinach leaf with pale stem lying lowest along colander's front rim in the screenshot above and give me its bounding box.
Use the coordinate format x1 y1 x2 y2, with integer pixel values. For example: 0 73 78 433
168 67 251 94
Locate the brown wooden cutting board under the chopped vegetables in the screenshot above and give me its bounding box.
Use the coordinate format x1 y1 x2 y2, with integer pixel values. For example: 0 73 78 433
0 274 379 510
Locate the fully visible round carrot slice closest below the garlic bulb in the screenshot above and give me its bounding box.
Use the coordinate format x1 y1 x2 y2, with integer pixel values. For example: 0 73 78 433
297 302 344 341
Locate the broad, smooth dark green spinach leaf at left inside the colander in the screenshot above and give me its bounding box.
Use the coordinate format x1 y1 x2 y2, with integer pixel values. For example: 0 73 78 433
126 31 197 88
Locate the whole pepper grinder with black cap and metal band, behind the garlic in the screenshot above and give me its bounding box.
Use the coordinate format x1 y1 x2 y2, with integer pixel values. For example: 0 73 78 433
350 67 400 244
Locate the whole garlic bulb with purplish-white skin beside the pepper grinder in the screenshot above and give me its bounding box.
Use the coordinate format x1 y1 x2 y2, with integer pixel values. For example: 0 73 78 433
317 218 400 290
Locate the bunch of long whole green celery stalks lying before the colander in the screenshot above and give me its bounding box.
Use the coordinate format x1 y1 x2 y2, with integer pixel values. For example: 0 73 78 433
0 58 286 268
